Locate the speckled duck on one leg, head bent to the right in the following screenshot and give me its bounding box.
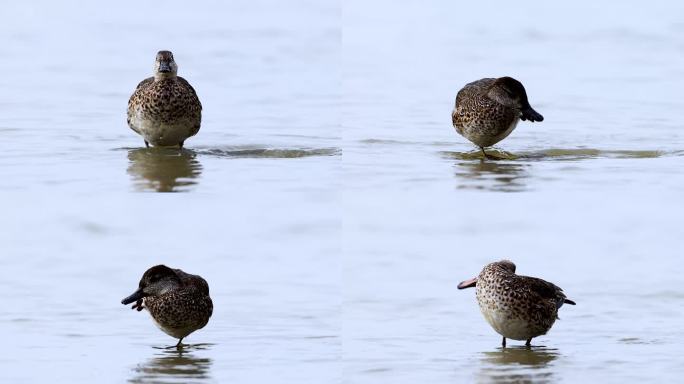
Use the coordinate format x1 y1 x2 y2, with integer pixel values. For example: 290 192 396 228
451 77 544 157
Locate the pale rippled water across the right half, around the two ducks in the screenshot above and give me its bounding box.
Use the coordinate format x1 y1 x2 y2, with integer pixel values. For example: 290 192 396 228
343 1 684 383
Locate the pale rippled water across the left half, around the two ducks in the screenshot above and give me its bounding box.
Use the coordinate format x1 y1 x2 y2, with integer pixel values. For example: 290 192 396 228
0 0 341 383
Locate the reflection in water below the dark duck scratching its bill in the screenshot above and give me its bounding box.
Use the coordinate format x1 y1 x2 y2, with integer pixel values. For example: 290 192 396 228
129 346 212 383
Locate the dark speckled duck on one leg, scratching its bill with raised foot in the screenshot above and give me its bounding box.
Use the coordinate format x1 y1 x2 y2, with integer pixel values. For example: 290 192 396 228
121 265 214 348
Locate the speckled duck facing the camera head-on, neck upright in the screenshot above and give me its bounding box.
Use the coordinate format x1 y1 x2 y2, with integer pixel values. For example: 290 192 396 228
128 51 202 148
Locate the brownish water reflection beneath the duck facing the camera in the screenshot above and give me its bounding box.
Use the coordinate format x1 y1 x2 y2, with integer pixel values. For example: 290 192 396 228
128 148 202 192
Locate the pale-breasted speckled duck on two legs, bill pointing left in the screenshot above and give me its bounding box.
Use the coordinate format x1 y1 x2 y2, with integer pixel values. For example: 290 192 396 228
458 260 575 347
